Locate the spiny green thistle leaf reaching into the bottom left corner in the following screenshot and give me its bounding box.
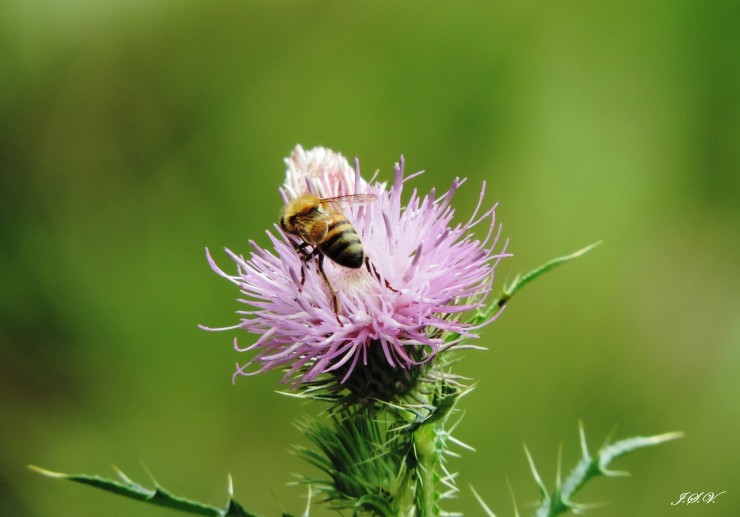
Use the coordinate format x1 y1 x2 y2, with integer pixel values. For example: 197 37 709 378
29 465 264 517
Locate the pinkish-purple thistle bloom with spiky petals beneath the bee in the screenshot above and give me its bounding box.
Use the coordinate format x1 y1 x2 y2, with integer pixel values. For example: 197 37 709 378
206 146 508 384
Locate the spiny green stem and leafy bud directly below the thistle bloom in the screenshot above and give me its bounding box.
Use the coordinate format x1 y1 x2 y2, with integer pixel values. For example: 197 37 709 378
296 382 468 516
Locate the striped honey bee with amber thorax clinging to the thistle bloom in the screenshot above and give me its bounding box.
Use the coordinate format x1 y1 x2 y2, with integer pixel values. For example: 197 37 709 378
280 193 387 318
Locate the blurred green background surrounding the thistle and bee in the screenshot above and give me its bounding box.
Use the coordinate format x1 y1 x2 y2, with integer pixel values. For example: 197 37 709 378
0 0 740 517
